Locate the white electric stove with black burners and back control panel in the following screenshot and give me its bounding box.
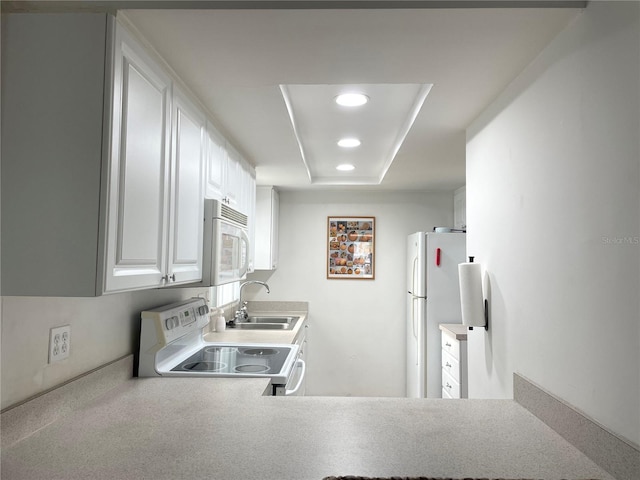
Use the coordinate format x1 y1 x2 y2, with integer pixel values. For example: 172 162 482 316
138 298 304 395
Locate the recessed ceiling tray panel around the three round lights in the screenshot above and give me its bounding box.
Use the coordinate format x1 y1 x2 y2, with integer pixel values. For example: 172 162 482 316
280 83 432 185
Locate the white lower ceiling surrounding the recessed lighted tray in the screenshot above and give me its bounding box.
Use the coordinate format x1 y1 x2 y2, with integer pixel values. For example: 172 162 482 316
125 4 580 191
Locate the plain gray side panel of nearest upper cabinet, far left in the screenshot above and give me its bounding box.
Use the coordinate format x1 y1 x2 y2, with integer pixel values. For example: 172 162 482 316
0 13 114 297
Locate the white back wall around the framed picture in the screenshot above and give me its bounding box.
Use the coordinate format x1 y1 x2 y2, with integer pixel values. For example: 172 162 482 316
246 190 453 396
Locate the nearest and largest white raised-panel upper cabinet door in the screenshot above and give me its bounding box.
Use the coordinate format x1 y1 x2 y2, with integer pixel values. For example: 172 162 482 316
104 25 171 292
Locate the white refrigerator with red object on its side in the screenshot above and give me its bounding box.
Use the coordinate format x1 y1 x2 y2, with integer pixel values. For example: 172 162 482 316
407 232 466 398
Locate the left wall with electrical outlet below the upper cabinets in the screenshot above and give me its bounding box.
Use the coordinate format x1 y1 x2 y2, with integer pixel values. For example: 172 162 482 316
0 288 209 409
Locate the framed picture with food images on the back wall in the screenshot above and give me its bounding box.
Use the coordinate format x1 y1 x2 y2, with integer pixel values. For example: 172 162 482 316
327 217 376 280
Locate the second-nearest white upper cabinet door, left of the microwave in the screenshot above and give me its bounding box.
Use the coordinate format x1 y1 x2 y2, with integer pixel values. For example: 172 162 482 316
166 87 205 284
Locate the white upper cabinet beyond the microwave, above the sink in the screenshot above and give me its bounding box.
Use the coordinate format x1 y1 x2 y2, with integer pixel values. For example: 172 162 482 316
255 186 280 270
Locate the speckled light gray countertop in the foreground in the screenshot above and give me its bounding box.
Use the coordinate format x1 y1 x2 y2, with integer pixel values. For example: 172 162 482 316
2 378 613 480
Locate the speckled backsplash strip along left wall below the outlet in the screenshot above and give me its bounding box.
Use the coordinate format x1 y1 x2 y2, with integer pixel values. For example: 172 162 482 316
0 355 133 449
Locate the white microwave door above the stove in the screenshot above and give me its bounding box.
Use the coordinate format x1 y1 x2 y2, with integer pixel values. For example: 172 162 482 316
211 219 249 285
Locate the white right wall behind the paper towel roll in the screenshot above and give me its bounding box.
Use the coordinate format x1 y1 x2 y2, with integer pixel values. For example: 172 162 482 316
467 2 640 444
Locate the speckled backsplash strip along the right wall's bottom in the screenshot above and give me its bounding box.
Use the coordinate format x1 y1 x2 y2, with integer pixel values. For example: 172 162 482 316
513 373 640 480
